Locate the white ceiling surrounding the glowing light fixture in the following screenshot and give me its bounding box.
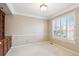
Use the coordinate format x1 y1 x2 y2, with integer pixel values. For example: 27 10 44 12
0 3 79 19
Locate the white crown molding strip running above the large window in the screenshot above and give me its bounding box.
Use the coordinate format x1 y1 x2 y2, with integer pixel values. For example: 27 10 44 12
49 4 79 20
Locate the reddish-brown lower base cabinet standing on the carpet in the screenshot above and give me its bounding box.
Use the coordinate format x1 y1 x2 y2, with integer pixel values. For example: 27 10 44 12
0 36 12 56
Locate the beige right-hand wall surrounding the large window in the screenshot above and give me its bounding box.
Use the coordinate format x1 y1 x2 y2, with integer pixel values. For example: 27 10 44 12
49 8 79 52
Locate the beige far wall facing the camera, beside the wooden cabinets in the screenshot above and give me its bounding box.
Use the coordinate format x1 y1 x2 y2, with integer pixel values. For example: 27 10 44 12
5 15 47 46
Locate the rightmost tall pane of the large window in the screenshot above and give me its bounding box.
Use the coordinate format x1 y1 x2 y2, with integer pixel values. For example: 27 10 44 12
67 14 75 40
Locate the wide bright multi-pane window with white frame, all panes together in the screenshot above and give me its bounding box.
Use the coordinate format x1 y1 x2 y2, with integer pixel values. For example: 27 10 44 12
52 12 76 41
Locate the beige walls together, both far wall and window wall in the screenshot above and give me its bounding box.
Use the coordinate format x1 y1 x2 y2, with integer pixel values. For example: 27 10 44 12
5 8 79 52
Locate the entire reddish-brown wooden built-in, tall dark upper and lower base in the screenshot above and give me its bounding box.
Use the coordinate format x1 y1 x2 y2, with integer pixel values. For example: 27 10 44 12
0 10 11 56
